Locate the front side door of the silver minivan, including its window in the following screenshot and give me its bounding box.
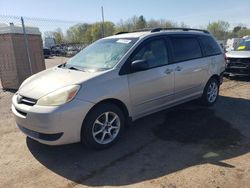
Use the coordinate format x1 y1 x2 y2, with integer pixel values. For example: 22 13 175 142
128 38 175 116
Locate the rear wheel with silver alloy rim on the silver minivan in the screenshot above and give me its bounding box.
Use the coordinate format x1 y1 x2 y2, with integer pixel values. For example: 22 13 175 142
201 78 220 106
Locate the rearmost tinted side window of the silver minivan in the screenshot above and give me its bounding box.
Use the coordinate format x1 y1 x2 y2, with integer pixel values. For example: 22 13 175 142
200 36 221 56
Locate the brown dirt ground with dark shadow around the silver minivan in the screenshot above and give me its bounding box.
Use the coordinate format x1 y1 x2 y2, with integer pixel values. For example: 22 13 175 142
0 58 250 188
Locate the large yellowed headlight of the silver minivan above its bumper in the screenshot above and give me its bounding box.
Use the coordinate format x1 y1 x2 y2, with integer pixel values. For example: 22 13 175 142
37 85 80 106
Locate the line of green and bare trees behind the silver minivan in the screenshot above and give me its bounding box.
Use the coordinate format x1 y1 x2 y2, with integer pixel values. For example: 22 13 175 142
45 16 250 44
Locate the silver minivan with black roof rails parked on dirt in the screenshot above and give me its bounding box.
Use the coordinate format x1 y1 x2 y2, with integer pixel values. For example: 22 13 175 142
12 28 225 149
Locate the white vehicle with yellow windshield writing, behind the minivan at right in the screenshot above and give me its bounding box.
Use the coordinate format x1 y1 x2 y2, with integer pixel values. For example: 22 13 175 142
225 39 250 76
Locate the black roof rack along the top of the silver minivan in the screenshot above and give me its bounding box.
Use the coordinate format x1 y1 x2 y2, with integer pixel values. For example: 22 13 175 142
115 27 209 35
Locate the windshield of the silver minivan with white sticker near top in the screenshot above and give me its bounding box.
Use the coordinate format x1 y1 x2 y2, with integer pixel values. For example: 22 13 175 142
66 38 138 71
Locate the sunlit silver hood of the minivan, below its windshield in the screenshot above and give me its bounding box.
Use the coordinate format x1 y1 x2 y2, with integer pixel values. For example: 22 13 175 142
18 67 102 99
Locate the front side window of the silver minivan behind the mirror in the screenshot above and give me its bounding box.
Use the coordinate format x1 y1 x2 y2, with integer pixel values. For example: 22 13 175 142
131 39 168 68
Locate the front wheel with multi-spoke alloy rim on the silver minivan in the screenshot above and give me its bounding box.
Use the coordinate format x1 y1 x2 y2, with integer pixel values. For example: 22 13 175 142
81 103 125 149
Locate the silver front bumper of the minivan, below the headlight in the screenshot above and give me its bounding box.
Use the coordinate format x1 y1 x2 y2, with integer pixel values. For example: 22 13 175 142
12 95 94 145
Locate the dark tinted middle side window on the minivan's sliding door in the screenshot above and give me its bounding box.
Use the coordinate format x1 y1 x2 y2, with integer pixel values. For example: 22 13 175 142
171 37 202 62
